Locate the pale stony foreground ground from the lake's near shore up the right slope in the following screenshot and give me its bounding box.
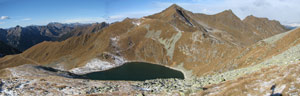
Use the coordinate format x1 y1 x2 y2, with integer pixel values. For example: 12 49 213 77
0 42 300 96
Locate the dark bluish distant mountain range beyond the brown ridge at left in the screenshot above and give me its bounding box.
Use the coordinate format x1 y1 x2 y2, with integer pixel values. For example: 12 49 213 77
0 22 108 51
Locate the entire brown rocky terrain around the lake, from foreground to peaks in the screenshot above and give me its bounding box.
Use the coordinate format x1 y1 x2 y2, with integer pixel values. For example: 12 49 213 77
0 5 300 96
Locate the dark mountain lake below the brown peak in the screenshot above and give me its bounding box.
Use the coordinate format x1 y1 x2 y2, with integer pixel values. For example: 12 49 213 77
81 62 184 81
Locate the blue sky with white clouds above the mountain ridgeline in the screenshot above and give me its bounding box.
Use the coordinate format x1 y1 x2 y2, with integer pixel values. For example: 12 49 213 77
0 0 300 28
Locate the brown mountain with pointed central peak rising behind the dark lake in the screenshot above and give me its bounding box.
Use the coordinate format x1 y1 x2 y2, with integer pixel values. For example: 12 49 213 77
0 5 285 77
